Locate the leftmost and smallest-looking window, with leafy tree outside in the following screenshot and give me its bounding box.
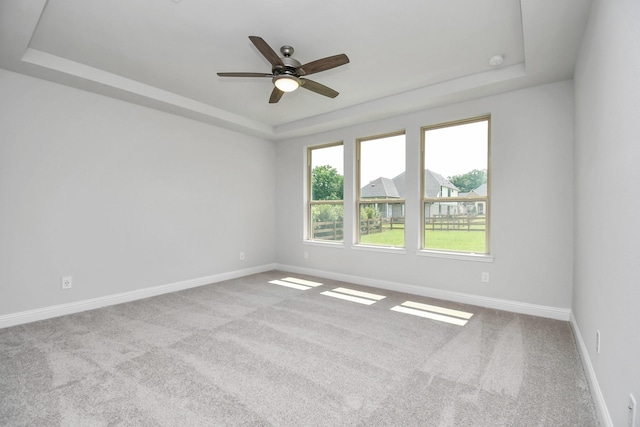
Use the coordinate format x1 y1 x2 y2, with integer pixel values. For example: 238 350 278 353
307 142 344 241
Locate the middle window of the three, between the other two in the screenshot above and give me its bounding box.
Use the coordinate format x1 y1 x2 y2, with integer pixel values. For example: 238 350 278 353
356 132 406 247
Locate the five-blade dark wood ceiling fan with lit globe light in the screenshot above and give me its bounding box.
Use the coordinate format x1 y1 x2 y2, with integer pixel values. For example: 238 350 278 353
218 36 349 104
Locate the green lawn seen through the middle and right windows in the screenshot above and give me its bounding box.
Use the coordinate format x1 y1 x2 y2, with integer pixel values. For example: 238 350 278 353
360 229 485 254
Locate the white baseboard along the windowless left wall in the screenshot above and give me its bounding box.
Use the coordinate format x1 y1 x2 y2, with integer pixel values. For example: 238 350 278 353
0 264 276 329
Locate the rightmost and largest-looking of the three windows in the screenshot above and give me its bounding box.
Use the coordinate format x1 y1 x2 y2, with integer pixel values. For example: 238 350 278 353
421 117 490 254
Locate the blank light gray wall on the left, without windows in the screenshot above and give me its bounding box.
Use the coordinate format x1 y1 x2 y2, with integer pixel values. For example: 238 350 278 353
0 70 275 315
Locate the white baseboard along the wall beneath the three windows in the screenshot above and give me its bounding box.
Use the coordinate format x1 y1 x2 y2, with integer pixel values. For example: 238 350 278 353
276 264 571 321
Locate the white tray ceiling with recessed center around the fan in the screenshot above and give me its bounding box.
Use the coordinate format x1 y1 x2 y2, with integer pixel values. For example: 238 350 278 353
0 0 591 139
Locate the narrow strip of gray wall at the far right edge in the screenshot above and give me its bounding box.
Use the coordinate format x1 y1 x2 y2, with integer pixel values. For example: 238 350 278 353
573 0 640 426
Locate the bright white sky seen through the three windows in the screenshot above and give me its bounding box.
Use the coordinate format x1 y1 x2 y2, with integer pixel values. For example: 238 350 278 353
311 121 488 184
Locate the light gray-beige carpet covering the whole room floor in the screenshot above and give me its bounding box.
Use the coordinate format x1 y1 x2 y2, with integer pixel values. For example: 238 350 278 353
0 271 597 427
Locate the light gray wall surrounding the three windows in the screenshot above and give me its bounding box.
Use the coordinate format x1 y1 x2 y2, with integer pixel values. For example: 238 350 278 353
276 81 573 313
